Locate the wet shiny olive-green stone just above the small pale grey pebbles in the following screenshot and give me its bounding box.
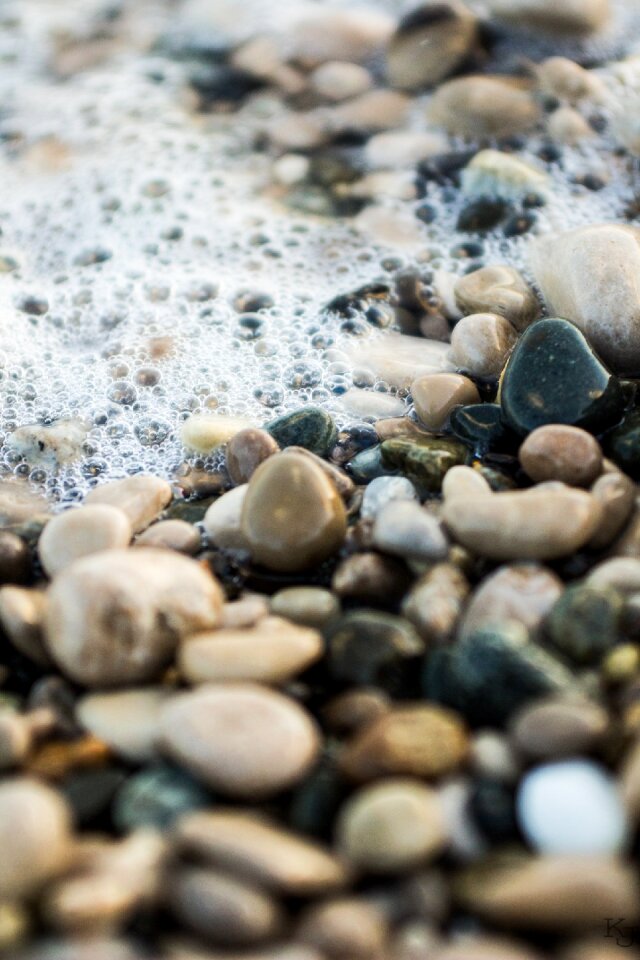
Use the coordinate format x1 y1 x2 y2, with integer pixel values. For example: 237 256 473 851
382 437 469 493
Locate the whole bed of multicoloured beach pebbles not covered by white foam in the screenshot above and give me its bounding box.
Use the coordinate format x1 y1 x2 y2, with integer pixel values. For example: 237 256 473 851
5 0 640 960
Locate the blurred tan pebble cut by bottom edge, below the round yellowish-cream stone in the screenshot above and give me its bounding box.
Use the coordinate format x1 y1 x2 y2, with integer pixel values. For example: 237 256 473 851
296 897 389 960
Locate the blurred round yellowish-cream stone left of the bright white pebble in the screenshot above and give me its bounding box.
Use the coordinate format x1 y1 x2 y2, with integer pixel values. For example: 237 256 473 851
337 779 447 873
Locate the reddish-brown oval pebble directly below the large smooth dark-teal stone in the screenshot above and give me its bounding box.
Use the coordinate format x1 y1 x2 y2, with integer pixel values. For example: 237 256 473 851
518 423 602 487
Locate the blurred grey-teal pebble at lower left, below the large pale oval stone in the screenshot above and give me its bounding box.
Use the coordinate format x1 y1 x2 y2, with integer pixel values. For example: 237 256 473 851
111 764 213 833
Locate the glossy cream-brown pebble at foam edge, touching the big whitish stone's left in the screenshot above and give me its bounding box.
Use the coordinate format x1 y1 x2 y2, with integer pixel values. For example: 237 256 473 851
454 264 540 332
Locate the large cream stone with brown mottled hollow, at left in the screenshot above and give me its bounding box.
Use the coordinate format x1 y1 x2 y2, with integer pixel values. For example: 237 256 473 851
45 547 222 686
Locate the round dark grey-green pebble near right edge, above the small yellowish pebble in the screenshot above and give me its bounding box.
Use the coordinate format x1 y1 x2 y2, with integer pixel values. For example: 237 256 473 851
546 584 624 666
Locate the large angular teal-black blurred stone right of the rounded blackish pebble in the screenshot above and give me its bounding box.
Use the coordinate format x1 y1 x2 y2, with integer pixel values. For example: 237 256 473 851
423 624 575 726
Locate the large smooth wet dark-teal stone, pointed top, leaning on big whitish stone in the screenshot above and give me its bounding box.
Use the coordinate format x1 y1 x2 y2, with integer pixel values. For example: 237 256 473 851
500 318 625 435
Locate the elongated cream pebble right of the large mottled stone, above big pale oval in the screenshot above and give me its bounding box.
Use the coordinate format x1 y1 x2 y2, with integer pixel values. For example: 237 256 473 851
178 617 323 685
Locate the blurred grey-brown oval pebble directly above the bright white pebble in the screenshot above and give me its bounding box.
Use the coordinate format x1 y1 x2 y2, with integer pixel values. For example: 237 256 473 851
510 697 609 760
